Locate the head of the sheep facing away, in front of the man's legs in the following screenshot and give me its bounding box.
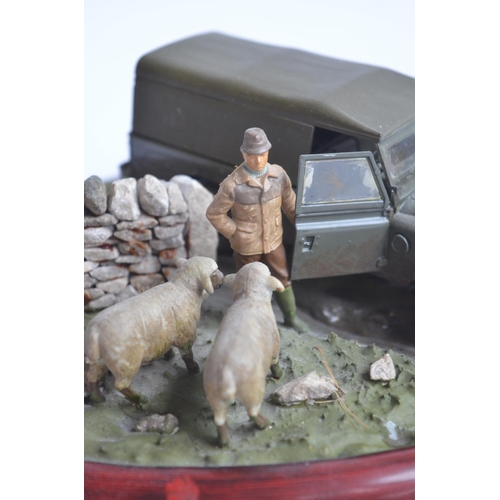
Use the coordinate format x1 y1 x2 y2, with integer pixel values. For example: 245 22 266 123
224 262 284 300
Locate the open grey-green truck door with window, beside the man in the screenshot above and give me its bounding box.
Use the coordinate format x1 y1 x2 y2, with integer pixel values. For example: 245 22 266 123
291 152 392 280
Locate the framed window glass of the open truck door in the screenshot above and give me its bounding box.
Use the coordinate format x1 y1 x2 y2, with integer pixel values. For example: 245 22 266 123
302 158 382 205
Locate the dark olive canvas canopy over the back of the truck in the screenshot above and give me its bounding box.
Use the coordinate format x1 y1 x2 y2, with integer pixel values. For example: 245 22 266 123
125 33 415 189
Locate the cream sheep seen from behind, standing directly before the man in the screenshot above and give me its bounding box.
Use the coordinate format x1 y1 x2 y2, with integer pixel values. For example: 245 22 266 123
203 262 283 447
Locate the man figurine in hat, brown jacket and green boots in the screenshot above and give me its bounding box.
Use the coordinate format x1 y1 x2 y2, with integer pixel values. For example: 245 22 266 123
207 128 308 333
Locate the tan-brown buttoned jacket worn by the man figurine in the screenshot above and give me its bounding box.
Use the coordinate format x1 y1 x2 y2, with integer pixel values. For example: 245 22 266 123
207 163 295 255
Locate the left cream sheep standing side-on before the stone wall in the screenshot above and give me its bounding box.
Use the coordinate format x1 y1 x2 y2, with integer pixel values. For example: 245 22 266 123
85 257 224 407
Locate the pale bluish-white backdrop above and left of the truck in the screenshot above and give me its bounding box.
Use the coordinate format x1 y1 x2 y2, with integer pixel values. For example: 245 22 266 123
84 0 415 181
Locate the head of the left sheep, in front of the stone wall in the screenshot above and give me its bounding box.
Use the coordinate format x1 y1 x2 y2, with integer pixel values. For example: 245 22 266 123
171 257 224 295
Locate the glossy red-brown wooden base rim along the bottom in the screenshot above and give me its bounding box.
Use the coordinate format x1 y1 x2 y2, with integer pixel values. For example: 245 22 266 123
85 447 415 500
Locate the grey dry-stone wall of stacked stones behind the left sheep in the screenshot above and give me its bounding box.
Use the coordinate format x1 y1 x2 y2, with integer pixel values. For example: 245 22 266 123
84 175 219 311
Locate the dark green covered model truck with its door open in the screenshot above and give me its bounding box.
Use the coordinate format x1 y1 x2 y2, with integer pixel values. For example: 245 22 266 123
122 33 415 283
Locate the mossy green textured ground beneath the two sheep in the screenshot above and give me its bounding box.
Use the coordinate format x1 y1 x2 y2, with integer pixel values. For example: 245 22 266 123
84 309 415 467
